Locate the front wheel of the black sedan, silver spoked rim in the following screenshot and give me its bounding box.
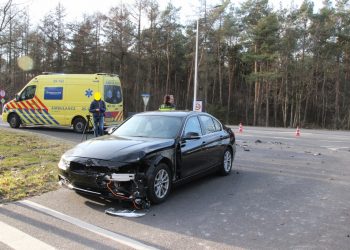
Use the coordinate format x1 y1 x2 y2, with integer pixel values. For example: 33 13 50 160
147 163 171 204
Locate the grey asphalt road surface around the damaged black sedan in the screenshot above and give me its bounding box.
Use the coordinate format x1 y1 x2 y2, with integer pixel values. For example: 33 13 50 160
0 120 350 249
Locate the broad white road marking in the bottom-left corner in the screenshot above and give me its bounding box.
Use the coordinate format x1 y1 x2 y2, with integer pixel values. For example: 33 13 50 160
0 221 55 250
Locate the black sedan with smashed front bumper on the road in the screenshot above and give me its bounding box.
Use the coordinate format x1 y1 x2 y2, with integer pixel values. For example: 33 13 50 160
58 111 236 208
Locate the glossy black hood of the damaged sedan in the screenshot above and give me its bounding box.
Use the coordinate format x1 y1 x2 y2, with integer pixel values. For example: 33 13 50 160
65 135 175 162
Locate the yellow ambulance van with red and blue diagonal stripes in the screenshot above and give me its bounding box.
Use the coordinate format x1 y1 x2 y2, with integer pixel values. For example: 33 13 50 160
2 73 123 133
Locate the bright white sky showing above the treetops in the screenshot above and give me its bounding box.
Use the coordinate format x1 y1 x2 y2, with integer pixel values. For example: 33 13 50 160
13 0 322 23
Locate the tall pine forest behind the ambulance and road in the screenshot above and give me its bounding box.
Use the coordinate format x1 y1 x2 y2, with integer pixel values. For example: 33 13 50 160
0 0 350 129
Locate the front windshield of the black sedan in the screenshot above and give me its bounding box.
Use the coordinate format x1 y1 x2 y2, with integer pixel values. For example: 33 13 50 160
113 115 182 139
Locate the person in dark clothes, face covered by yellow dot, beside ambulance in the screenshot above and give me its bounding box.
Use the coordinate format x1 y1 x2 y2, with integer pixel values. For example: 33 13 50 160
89 92 106 137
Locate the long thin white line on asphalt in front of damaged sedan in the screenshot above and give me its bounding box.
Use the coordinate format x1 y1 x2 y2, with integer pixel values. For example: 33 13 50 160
18 200 156 250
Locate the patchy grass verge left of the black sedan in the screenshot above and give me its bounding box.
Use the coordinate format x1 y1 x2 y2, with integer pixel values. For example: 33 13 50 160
0 128 73 203
